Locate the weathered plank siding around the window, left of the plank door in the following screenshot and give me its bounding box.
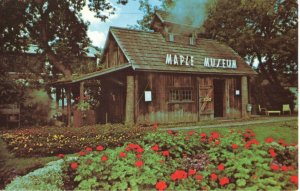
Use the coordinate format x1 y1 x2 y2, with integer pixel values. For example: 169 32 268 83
136 73 198 123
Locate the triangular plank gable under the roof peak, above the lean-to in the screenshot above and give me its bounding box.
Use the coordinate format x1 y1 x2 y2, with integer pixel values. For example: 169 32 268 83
102 35 128 68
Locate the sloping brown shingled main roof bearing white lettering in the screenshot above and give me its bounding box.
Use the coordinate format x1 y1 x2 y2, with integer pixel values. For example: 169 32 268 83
110 27 256 75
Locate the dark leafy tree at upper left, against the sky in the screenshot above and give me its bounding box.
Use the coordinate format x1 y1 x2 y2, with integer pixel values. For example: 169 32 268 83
0 0 127 78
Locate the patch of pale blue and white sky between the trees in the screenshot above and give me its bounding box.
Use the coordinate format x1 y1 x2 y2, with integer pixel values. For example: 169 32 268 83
82 0 160 48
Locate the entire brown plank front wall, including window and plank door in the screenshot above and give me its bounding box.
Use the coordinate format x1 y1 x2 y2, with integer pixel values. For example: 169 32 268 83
135 73 241 123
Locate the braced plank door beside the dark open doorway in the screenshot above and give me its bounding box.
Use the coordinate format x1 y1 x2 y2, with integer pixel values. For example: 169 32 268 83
198 77 214 119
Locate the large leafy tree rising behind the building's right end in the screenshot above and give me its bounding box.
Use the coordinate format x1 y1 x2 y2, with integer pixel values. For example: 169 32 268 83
204 0 298 85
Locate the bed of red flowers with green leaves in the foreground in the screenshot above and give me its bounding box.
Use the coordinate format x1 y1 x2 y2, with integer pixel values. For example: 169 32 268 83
61 129 298 190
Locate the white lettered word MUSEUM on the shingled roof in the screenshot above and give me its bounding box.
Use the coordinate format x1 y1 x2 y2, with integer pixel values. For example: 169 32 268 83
203 58 237 69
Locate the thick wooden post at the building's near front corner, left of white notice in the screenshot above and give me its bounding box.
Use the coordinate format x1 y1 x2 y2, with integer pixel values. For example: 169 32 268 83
125 76 134 125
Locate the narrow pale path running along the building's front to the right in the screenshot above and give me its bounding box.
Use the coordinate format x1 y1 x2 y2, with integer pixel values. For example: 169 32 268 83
159 116 298 131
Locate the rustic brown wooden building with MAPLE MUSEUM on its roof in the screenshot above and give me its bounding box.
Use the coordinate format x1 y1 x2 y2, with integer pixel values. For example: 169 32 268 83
54 11 256 124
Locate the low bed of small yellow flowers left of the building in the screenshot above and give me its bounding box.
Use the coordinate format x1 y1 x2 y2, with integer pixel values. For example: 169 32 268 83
0 124 146 157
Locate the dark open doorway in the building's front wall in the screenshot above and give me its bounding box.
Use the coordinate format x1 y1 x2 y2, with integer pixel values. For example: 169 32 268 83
213 79 225 117
